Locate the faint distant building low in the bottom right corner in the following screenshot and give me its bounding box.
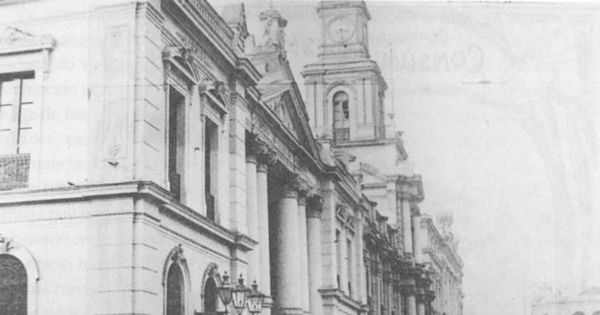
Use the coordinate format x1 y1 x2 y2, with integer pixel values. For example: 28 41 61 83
531 287 600 315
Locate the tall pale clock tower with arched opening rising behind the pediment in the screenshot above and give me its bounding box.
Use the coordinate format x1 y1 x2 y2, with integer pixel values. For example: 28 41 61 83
302 1 387 147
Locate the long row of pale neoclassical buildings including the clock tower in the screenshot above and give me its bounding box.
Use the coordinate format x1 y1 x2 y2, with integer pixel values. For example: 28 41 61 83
0 0 462 315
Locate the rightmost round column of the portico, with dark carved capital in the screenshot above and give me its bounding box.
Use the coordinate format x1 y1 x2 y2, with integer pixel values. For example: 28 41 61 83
306 195 323 315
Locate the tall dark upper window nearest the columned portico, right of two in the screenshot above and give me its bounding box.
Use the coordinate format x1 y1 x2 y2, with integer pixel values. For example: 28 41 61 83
204 118 219 221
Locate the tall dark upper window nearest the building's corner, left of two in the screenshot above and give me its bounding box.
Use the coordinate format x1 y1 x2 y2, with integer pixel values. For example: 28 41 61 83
168 87 185 200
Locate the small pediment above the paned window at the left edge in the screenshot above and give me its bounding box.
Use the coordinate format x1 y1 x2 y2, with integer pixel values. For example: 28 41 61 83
0 26 56 54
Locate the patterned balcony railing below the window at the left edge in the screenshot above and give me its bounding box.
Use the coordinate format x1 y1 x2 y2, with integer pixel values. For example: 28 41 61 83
0 153 30 190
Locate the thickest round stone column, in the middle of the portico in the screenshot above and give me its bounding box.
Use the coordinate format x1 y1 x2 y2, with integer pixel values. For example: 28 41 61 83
272 178 302 315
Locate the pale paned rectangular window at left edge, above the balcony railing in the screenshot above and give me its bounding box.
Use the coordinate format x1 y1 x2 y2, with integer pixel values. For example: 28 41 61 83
0 72 35 154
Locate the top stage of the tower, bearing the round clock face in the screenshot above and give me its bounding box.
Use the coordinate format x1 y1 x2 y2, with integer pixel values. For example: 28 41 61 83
317 1 371 58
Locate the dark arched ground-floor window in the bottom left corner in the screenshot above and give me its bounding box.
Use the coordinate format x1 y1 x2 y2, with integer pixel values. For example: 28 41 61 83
0 254 27 315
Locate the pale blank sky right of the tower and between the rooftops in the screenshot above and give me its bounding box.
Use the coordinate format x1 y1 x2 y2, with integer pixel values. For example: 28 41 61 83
212 0 600 315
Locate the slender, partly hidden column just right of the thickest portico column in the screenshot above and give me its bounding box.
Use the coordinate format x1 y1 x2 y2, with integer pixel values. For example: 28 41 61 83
298 190 310 314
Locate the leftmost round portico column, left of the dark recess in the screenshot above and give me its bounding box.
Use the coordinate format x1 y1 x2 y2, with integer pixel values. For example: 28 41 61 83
256 145 275 315
